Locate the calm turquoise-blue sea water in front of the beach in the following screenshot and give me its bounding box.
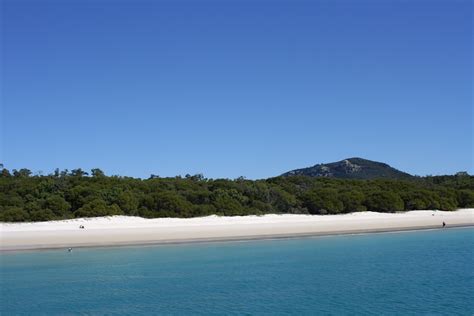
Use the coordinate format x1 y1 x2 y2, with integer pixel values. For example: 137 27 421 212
0 228 474 315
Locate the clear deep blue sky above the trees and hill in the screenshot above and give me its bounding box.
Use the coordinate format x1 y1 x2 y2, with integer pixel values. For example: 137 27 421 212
0 0 474 179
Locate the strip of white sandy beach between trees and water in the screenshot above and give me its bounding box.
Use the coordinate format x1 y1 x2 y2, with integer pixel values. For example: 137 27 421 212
0 209 474 251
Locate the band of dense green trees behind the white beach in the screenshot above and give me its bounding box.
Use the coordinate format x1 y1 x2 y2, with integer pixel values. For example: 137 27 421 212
0 169 474 222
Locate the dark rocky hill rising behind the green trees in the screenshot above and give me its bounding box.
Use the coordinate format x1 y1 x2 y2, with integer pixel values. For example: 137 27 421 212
282 157 413 179
